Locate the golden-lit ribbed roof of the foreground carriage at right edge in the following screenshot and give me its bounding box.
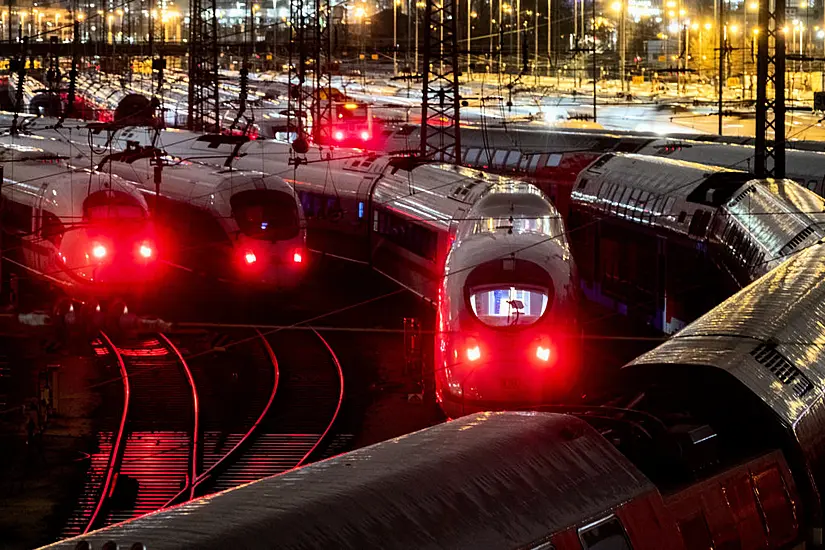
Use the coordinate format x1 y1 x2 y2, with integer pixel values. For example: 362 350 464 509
623 241 825 512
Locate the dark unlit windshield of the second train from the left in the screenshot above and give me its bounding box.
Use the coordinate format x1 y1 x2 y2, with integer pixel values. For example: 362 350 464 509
229 189 300 241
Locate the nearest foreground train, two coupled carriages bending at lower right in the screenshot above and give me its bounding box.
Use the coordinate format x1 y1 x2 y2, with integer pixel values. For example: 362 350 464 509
53 243 825 550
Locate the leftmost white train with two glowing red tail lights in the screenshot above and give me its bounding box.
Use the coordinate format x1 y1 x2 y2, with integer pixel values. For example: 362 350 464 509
0 141 158 305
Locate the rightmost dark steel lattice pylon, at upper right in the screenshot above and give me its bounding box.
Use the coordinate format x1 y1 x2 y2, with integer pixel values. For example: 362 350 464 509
755 0 785 178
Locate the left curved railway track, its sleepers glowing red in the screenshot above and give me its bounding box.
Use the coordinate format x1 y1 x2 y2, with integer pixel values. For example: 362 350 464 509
64 333 200 536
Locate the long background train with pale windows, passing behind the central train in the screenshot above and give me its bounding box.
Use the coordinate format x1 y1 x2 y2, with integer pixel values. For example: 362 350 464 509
374 125 825 215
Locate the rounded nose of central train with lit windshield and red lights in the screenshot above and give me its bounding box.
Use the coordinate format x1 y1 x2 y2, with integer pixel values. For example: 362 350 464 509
434 183 580 418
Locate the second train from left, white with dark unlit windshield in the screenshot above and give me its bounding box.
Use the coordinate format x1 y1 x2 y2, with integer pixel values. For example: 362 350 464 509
0 129 309 291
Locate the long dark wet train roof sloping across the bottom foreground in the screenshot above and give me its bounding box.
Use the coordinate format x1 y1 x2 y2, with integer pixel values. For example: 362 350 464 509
51 412 656 549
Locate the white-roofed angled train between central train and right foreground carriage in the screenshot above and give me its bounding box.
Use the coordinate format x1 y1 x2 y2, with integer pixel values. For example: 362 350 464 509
569 153 825 333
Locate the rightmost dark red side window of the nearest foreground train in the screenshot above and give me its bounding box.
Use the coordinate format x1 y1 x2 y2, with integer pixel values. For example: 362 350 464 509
753 466 799 547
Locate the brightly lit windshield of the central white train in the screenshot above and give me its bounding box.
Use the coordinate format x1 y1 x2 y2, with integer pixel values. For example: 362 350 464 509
470 286 549 327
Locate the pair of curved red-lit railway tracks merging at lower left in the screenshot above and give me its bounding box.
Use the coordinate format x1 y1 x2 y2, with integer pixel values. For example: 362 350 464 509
58 331 344 537
